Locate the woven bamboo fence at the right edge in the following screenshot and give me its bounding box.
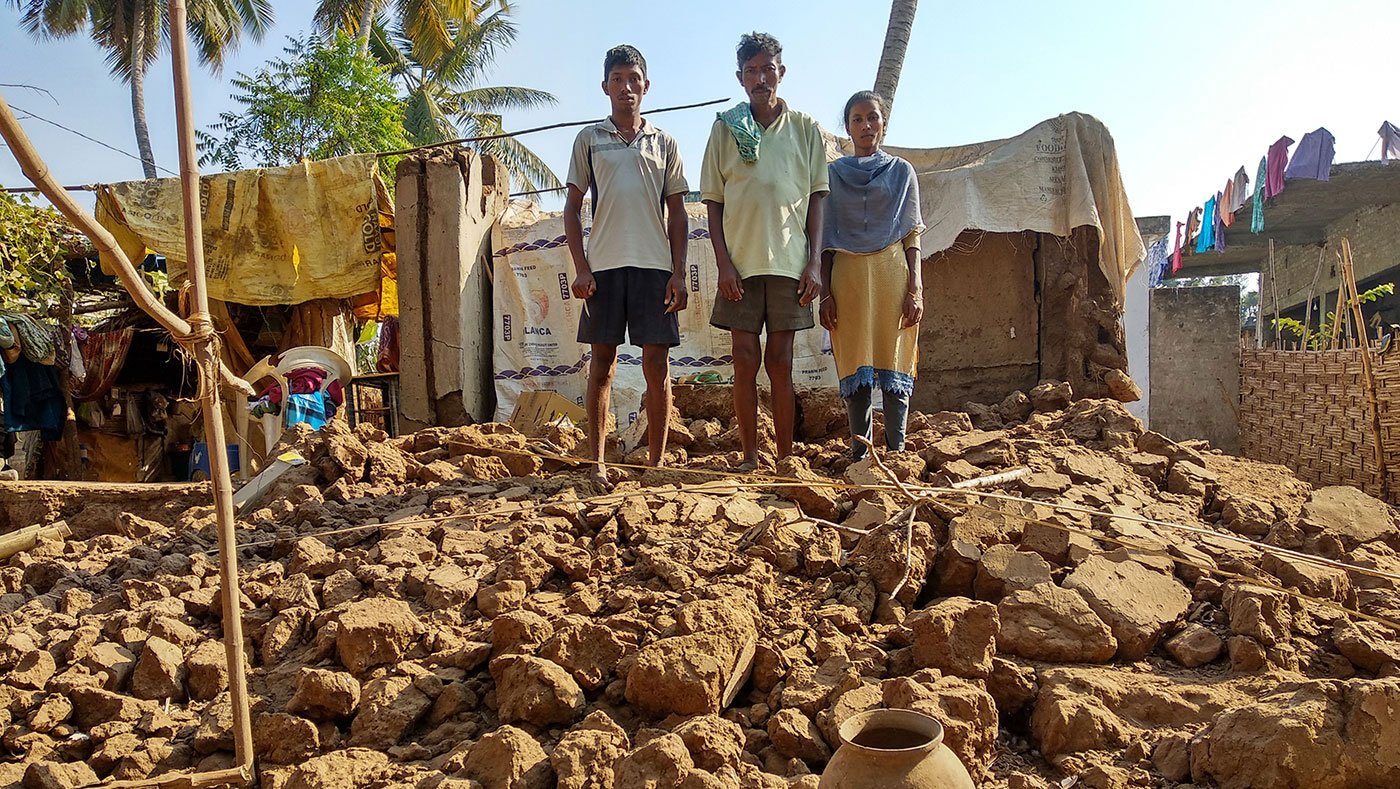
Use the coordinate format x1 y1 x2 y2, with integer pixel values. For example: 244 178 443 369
1239 348 1400 504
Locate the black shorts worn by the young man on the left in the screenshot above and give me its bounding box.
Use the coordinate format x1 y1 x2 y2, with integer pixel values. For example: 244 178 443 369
578 266 680 348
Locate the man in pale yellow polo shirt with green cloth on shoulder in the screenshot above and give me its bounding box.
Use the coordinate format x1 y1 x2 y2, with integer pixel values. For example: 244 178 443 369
700 32 827 469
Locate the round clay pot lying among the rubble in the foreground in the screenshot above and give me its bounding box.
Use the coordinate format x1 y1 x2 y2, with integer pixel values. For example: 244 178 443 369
818 709 974 789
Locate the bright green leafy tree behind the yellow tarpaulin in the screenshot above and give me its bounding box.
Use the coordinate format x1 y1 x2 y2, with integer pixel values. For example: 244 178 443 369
197 34 410 169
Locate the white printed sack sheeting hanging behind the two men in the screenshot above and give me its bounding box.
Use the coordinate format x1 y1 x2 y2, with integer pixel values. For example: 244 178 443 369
493 204 836 428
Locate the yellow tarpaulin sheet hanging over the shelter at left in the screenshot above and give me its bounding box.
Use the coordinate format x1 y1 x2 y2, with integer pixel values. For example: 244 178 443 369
97 154 384 306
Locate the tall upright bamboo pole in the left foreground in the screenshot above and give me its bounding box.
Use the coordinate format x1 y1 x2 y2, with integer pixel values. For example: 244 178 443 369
169 0 253 781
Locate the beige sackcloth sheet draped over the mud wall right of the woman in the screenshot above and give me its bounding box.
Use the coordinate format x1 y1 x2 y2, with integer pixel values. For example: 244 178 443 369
885 112 1147 305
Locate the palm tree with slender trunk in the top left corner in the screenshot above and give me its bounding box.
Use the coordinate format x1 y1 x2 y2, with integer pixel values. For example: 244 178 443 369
10 0 273 178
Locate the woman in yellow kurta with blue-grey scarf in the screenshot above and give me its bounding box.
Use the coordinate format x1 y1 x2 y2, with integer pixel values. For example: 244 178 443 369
820 91 924 460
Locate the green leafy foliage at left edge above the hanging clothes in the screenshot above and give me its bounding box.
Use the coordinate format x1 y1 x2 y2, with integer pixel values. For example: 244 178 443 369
0 192 73 313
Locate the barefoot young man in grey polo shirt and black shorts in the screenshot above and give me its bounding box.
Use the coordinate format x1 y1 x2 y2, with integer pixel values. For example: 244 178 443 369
564 45 690 488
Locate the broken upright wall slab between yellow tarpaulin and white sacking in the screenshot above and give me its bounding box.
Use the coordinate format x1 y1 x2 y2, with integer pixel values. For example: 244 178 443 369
395 148 510 431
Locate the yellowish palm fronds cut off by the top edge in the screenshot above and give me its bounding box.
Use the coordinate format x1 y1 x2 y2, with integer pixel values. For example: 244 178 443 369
315 0 492 62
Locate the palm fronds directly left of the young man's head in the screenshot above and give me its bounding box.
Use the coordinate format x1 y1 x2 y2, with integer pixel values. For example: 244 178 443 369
370 3 560 189
